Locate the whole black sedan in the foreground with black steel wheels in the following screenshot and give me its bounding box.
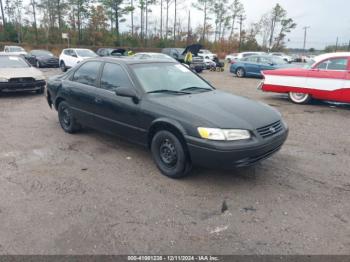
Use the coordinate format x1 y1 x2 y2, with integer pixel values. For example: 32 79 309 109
47 58 288 178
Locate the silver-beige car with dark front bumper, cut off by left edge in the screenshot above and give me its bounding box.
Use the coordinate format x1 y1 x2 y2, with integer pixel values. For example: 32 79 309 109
0 55 46 94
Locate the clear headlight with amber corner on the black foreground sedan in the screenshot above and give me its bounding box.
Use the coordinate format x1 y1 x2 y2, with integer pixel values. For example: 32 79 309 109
197 127 251 141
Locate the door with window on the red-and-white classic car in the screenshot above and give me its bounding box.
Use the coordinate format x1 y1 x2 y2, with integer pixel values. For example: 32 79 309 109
306 57 348 101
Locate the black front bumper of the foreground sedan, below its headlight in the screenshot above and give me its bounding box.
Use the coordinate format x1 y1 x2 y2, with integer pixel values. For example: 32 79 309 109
186 127 288 169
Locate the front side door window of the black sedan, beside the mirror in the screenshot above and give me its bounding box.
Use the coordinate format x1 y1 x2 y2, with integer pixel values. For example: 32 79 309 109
101 63 132 91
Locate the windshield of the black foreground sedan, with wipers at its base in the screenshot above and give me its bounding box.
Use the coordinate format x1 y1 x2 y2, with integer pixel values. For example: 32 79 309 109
132 63 214 94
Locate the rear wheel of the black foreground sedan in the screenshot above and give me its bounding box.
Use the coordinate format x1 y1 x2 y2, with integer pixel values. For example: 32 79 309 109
57 101 81 134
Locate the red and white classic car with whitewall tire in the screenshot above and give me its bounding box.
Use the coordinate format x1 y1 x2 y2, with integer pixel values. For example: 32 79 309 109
258 52 350 104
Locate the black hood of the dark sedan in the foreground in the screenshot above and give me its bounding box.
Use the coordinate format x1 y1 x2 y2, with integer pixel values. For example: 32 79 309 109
151 90 281 130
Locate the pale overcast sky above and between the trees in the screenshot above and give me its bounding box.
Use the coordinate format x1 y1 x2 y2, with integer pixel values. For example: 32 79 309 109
24 0 350 48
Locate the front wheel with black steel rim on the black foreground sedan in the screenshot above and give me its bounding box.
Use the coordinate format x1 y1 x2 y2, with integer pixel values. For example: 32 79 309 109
151 130 191 178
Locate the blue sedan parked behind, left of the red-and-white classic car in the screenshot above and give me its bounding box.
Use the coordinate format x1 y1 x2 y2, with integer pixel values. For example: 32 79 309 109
230 55 290 77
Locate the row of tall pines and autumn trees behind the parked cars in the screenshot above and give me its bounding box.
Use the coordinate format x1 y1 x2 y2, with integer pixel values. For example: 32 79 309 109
0 0 296 51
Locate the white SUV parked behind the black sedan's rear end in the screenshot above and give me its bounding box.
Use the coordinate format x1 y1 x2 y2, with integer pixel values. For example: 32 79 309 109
59 48 97 72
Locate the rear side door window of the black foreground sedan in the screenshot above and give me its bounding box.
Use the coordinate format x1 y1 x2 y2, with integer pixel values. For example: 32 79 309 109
72 62 101 86
